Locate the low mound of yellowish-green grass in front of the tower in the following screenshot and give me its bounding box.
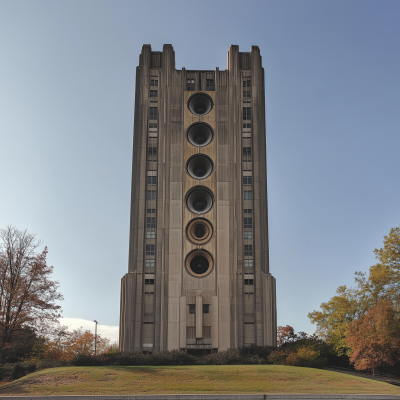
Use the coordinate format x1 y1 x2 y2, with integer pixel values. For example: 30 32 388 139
0 365 400 396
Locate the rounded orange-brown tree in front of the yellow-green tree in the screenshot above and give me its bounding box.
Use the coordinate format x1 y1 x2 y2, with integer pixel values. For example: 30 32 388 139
346 299 400 375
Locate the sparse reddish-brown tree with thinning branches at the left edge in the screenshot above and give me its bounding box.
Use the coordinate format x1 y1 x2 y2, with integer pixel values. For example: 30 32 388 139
0 226 63 364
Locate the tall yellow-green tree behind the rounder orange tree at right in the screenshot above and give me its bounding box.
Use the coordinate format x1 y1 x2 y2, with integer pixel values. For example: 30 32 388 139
308 227 400 356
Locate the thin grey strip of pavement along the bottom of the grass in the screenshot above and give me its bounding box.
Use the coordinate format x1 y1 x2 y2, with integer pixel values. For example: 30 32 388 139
0 394 400 400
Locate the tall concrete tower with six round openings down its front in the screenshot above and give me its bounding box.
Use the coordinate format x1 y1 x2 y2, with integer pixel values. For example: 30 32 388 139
120 44 276 354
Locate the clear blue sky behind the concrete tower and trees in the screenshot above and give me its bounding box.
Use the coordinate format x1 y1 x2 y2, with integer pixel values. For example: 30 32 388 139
0 0 400 332
